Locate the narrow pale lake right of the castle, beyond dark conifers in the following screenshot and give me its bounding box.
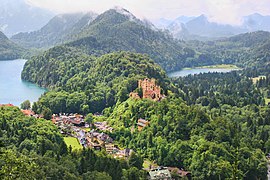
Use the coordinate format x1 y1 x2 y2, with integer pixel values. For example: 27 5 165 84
168 68 239 77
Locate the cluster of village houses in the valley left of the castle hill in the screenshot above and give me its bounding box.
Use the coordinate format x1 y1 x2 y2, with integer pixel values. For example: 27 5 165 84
52 114 132 158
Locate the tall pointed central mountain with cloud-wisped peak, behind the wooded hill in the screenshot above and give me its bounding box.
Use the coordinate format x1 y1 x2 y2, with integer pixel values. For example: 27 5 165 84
63 9 195 71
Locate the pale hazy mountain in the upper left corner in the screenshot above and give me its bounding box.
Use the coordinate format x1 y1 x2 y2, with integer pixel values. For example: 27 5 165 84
0 0 54 36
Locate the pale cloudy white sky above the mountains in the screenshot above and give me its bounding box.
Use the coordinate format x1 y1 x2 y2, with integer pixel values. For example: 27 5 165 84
26 0 270 25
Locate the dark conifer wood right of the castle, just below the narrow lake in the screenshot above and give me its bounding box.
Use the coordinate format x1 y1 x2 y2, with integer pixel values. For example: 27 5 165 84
173 71 265 108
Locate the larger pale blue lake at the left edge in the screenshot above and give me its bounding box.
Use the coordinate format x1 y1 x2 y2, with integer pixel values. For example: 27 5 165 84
0 59 46 106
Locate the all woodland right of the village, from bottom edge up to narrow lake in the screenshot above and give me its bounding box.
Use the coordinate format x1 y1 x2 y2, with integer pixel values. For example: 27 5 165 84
103 73 270 179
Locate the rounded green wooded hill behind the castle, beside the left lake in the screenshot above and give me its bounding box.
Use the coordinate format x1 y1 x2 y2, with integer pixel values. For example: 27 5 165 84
22 47 170 113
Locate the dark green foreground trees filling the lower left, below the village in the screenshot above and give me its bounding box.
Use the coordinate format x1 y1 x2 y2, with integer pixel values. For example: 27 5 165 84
0 107 146 180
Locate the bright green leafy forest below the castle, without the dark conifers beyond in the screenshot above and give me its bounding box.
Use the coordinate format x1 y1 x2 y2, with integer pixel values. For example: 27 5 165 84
104 96 270 179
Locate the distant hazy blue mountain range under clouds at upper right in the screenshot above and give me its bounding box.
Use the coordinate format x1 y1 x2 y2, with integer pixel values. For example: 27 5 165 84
154 13 270 40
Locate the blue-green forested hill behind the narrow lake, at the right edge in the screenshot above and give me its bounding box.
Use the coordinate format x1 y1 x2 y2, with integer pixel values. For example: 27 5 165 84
190 31 270 68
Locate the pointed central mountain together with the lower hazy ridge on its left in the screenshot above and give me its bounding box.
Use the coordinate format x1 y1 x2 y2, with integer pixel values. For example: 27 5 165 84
11 8 195 71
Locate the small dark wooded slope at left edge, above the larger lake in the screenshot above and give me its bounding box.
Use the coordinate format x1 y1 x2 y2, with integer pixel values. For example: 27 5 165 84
0 31 23 60
